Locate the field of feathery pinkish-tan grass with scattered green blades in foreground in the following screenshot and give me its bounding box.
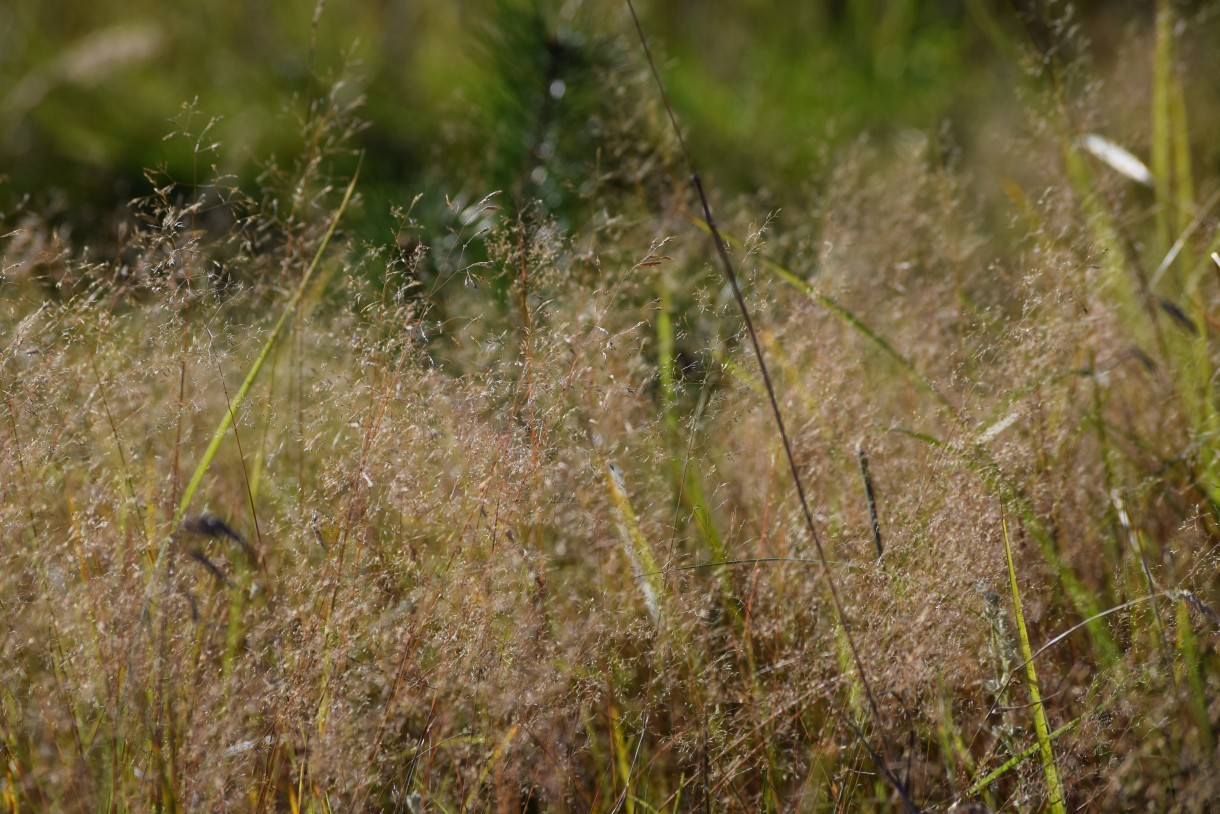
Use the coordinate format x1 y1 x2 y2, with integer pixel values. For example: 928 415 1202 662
0 4 1220 813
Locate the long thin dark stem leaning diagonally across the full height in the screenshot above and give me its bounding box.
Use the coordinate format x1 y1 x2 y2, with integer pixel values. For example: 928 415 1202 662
627 0 919 812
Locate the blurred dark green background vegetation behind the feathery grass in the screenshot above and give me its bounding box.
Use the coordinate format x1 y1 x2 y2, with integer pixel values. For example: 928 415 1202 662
0 0 1216 239
